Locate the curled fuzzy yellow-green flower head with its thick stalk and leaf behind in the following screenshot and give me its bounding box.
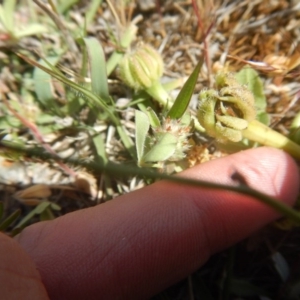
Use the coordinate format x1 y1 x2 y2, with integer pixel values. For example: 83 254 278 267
198 68 300 158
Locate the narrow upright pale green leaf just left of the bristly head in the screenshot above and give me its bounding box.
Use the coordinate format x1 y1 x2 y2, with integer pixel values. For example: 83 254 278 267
135 110 150 162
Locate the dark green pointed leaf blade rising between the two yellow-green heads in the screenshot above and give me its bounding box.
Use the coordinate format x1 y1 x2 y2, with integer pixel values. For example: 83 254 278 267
168 59 203 119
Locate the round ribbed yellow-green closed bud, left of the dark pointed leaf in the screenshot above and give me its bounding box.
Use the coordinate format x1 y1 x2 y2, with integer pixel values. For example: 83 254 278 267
120 43 163 90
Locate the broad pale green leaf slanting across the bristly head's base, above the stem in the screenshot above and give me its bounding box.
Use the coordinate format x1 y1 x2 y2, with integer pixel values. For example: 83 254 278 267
141 133 177 164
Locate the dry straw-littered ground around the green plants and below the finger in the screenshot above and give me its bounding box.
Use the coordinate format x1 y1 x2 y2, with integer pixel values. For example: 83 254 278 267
0 0 300 299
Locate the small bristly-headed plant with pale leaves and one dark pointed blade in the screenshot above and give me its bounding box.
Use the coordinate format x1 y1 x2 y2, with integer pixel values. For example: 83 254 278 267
135 61 203 167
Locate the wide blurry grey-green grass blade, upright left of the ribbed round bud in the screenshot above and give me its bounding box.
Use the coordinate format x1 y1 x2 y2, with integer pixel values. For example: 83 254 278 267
82 37 110 102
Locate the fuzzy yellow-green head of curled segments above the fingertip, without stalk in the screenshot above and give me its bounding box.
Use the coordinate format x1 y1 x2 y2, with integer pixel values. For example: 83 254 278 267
198 73 256 142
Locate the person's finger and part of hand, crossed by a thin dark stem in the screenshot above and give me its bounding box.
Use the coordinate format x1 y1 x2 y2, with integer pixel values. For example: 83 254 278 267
0 148 299 300
